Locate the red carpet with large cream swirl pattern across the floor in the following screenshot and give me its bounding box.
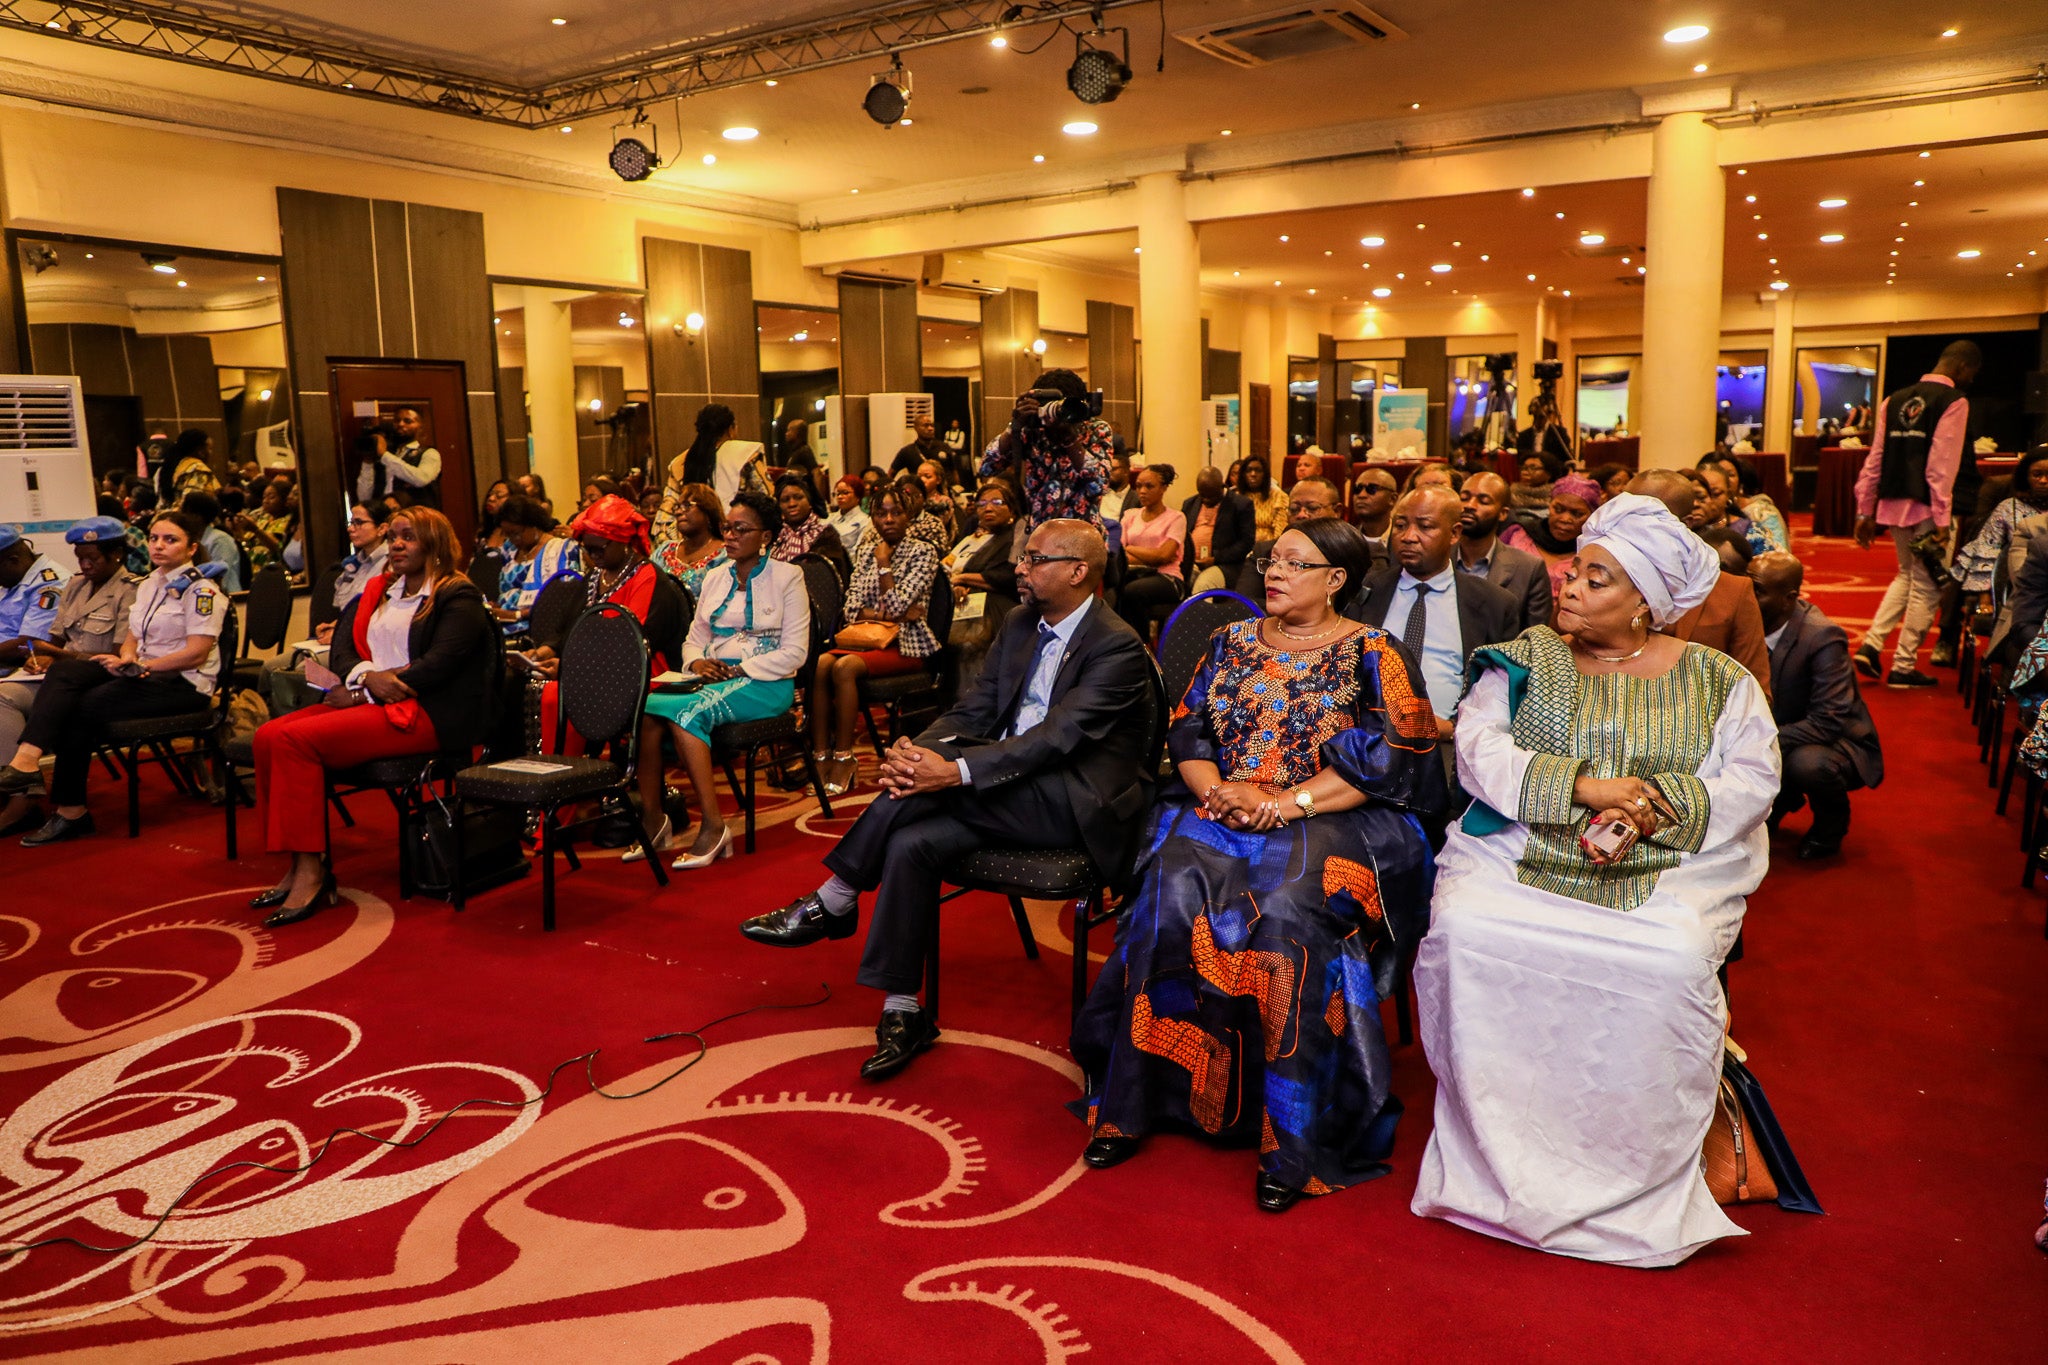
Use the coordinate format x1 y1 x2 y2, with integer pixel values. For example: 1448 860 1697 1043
0 519 2048 1365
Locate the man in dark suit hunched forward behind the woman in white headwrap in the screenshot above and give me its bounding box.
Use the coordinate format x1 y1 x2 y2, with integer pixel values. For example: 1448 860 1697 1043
1749 551 1884 860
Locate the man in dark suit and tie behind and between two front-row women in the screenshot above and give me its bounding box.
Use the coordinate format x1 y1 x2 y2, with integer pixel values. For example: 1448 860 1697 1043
1343 485 1522 810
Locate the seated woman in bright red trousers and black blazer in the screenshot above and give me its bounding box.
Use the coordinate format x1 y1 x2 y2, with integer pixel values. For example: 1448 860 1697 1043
250 508 496 927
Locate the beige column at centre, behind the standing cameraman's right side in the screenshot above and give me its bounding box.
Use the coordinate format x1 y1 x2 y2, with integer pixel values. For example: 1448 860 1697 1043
1137 172 1202 477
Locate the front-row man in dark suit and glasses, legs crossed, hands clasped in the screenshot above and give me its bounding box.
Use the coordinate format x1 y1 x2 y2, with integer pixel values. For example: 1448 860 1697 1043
739 520 1163 1081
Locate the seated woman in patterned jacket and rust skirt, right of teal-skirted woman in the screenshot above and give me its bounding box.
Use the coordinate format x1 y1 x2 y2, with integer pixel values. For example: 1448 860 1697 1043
807 479 938 796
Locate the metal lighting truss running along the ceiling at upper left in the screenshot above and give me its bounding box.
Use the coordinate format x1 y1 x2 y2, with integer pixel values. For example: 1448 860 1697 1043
0 0 1155 127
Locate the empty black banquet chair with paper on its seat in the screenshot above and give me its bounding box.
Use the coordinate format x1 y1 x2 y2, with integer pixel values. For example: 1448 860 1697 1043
455 605 668 929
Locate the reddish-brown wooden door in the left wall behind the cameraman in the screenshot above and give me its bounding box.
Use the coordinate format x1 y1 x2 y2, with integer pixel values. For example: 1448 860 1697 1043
328 360 477 553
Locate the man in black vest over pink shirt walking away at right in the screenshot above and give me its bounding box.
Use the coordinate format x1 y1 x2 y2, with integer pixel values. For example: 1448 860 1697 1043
1855 342 1985 688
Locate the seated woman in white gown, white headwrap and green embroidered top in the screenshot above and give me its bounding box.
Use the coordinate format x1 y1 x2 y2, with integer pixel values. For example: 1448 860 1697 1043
1411 493 1778 1267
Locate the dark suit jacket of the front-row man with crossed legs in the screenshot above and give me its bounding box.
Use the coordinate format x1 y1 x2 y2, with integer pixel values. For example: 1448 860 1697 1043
918 598 1165 882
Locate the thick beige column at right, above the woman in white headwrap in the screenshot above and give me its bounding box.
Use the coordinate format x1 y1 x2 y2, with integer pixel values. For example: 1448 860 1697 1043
1636 115 1726 469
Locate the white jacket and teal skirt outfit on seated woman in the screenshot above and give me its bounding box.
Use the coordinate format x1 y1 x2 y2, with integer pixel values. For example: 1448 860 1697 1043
647 555 811 745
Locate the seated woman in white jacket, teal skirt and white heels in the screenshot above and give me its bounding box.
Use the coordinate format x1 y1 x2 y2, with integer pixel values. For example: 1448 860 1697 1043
629 491 821 872
